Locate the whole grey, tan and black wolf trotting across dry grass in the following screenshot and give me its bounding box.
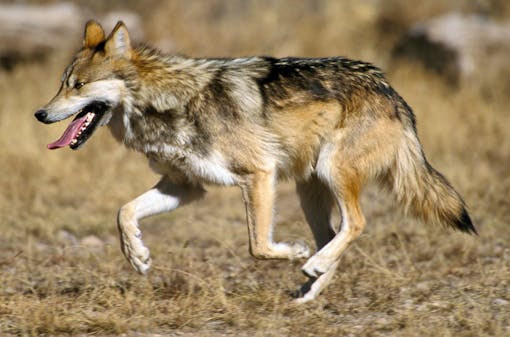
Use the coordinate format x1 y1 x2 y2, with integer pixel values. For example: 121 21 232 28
35 21 476 303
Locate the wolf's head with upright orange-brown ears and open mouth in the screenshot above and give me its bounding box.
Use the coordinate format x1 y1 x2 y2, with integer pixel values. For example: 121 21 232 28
35 20 132 149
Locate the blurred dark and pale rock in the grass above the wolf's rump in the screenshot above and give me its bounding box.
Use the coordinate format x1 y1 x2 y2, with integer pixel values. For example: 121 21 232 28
392 13 510 84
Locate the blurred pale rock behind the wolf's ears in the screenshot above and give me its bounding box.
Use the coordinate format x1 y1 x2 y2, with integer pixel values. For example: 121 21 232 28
0 3 144 70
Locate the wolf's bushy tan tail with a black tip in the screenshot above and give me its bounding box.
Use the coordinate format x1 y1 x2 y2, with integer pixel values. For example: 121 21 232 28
385 97 477 234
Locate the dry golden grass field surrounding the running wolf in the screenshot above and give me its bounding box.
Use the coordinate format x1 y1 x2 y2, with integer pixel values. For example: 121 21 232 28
0 0 510 337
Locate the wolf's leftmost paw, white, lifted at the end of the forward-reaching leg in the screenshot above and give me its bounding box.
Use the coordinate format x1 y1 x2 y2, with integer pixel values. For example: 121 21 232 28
121 230 151 275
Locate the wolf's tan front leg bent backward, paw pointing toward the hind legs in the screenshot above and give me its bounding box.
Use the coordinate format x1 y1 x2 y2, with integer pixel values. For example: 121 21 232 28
241 171 310 259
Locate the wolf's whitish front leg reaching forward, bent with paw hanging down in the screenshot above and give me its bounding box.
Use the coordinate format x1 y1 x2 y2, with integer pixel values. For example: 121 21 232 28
117 177 205 274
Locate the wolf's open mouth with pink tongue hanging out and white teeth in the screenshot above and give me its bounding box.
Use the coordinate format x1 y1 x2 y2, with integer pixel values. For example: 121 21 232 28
48 102 107 150
